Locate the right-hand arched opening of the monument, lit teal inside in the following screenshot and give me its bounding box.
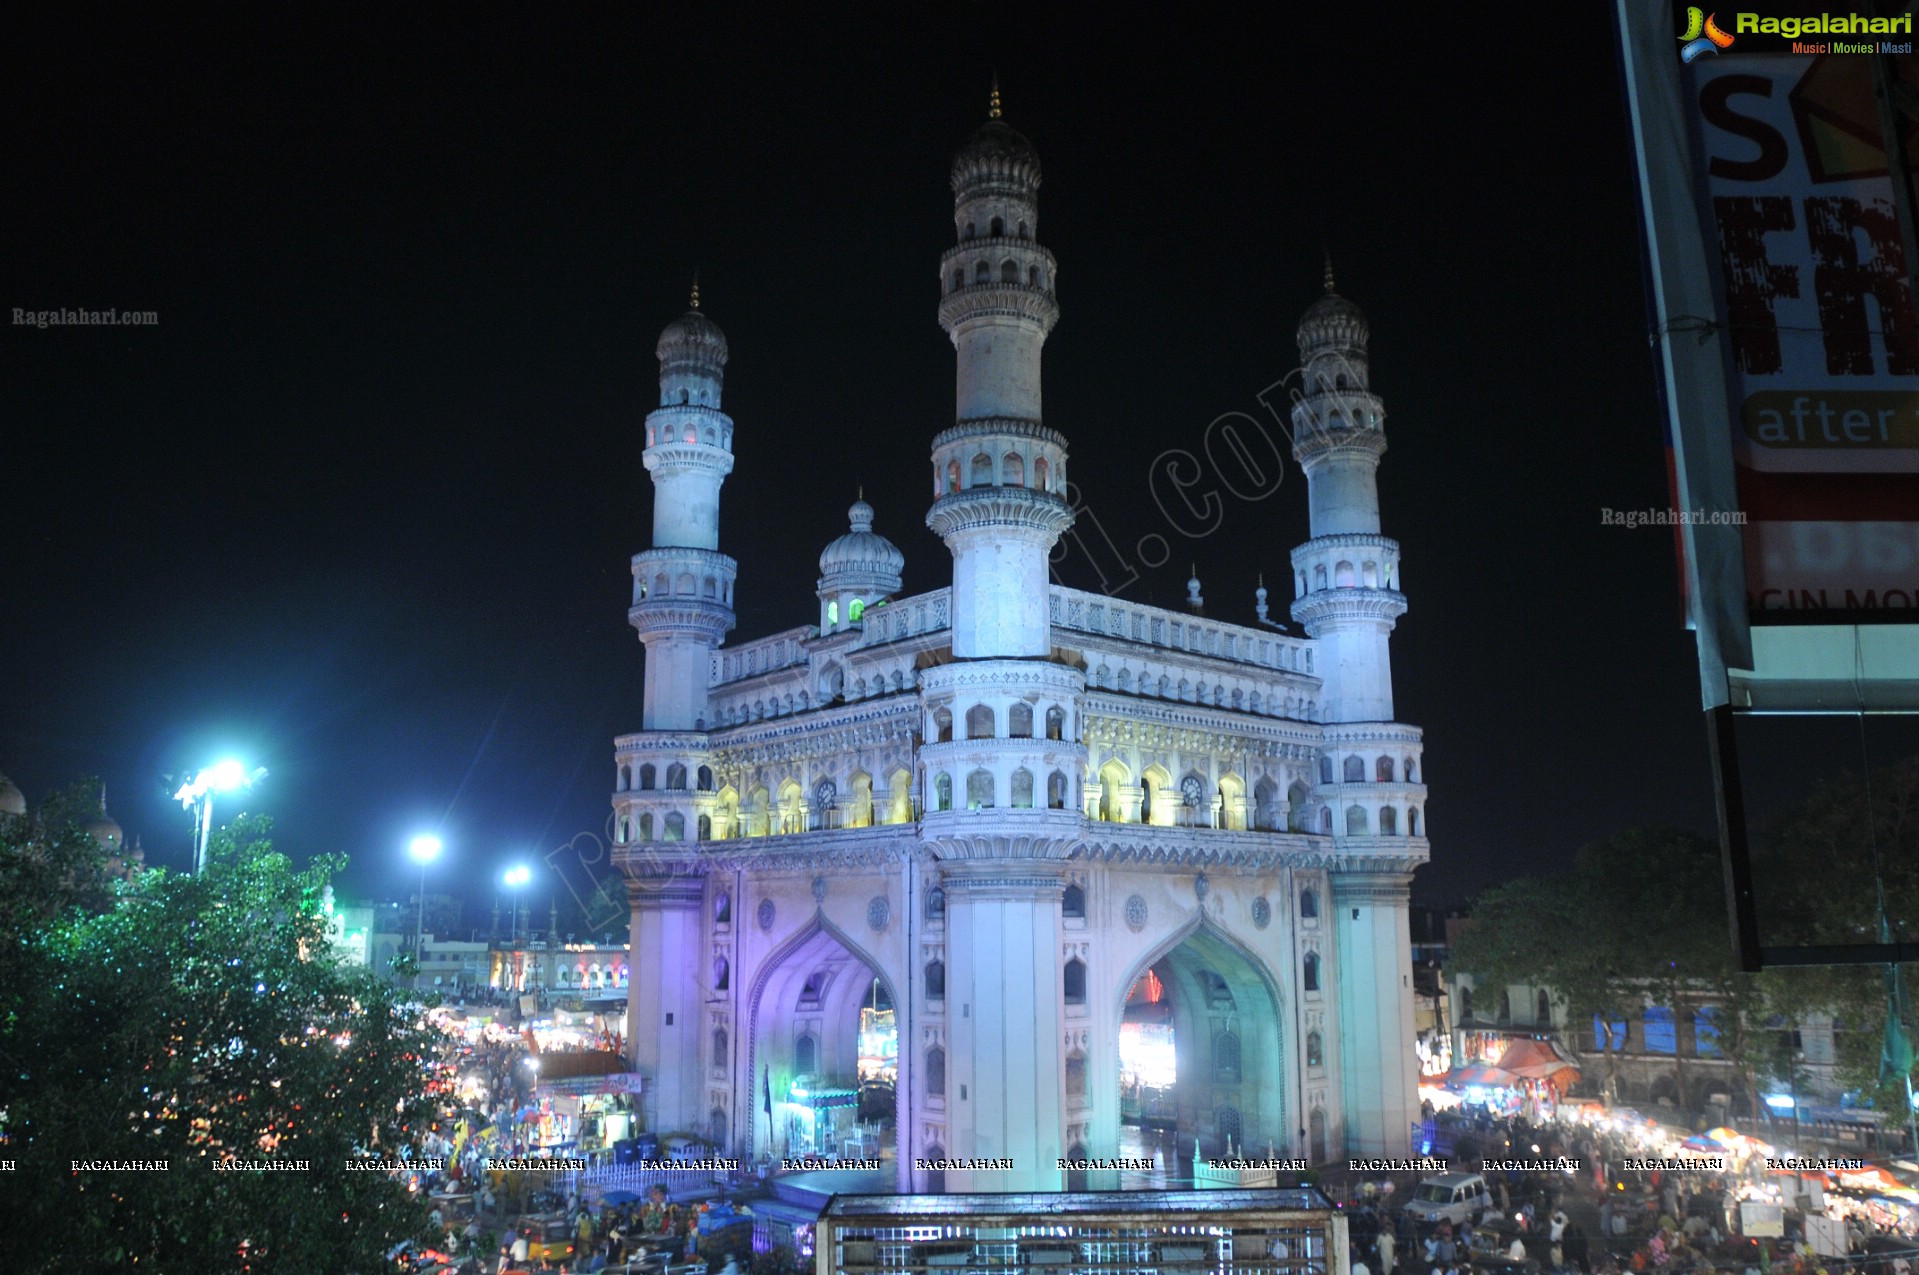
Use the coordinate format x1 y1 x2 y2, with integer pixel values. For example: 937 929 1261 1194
1119 924 1291 1156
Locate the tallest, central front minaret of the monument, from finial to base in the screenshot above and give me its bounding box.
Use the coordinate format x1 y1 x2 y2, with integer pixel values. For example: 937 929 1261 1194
921 86 1086 1191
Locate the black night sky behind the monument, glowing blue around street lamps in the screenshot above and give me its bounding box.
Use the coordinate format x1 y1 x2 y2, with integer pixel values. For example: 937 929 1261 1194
0 6 1888 925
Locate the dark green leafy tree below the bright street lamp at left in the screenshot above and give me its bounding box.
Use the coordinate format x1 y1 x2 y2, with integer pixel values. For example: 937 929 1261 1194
0 798 430 1273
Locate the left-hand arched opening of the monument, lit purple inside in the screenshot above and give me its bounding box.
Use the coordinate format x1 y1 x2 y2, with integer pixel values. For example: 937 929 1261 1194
743 920 898 1158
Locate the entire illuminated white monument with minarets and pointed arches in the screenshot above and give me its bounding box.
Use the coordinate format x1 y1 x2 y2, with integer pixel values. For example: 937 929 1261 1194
612 98 1428 1191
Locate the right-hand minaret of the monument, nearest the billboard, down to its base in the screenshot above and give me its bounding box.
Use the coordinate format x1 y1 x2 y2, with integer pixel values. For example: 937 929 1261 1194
1293 261 1426 1154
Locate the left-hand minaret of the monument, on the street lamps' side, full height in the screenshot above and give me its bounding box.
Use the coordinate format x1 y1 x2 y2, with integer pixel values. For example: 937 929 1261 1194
612 282 737 1129
